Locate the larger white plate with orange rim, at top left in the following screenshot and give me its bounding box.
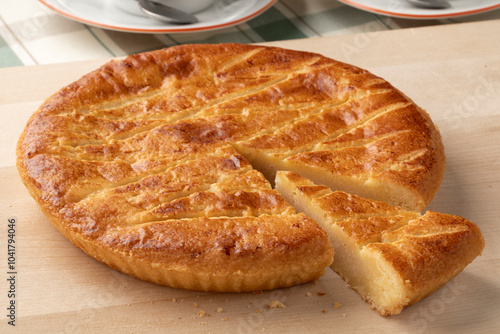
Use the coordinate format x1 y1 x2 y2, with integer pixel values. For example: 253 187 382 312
39 0 277 33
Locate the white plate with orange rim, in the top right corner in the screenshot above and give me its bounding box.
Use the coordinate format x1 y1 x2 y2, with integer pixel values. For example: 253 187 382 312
339 0 500 19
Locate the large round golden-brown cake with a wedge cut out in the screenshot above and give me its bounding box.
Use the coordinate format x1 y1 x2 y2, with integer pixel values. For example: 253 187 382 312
17 44 445 292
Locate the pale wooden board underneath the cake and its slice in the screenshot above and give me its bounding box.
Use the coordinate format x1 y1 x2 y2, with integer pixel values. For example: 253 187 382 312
0 21 500 334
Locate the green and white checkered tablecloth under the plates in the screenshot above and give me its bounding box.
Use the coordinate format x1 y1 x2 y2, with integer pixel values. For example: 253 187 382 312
0 0 500 67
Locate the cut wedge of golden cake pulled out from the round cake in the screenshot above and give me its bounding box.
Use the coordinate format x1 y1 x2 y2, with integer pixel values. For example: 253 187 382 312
276 171 484 315
